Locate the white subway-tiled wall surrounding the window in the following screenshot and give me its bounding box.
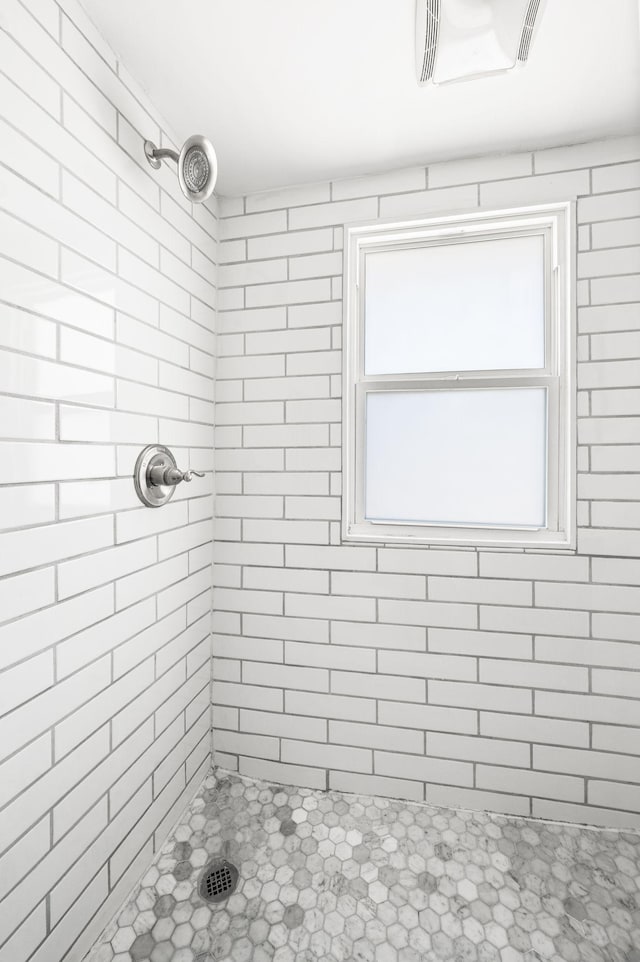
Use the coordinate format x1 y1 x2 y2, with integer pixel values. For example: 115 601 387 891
214 138 640 826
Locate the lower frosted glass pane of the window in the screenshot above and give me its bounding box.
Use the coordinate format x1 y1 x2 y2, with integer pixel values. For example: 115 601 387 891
365 388 546 527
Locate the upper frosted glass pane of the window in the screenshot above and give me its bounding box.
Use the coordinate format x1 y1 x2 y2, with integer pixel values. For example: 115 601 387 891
365 236 544 375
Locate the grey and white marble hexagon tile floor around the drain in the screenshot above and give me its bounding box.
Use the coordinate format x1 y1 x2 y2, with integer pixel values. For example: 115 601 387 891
87 772 640 962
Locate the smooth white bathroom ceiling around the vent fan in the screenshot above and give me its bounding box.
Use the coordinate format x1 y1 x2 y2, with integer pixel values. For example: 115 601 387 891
82 0 640 195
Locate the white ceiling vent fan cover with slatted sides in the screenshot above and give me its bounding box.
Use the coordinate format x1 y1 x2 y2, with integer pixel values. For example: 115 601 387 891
416 0 545 84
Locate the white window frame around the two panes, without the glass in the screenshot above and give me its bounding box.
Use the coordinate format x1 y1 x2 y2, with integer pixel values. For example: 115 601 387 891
342 201 576 549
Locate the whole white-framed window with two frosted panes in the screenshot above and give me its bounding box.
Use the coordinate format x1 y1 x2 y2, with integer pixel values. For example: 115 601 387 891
343 203 575 548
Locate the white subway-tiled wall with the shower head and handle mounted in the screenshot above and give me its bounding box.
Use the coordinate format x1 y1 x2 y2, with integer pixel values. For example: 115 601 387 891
0 0 216 962
